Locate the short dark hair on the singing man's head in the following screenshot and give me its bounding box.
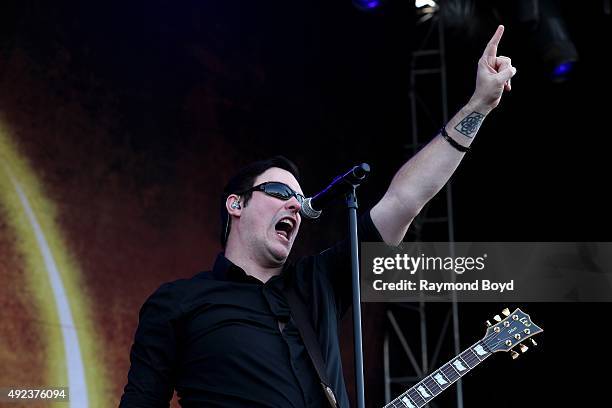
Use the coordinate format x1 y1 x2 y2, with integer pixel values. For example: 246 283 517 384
219 156 300 248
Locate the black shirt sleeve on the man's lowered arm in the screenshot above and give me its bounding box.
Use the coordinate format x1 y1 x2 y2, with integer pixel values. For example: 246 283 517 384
119 283 179 408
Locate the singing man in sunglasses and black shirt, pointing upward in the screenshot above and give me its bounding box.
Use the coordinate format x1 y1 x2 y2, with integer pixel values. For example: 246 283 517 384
120 26 516 408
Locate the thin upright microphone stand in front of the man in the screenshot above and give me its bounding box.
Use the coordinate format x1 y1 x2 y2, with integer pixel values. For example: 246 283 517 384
346 163 370 408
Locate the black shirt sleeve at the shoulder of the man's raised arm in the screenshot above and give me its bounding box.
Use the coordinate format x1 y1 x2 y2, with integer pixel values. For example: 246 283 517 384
317 210 384 317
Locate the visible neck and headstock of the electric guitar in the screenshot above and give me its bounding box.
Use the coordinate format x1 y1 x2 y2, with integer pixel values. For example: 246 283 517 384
384 308 543 408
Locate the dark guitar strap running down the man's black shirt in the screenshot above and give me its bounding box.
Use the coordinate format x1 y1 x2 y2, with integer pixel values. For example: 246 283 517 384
283 279 339 408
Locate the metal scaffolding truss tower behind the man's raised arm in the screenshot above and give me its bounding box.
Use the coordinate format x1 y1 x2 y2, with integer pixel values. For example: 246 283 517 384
383 9 463 408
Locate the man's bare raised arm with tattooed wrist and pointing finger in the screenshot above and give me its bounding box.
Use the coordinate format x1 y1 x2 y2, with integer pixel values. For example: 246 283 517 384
370 26 516 245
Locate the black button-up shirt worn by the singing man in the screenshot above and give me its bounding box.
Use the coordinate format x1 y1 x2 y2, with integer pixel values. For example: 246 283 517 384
120 211 382 408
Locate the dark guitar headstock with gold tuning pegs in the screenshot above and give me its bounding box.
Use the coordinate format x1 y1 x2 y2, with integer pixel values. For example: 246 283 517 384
482 308 543 358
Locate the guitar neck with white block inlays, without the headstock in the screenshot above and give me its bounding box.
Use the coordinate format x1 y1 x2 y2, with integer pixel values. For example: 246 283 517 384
385 340 492 408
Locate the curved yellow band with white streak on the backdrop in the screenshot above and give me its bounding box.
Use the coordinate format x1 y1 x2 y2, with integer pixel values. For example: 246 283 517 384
0 118 109 408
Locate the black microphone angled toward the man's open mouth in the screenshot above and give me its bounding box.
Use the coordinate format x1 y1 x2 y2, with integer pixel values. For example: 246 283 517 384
300 163 370 219
